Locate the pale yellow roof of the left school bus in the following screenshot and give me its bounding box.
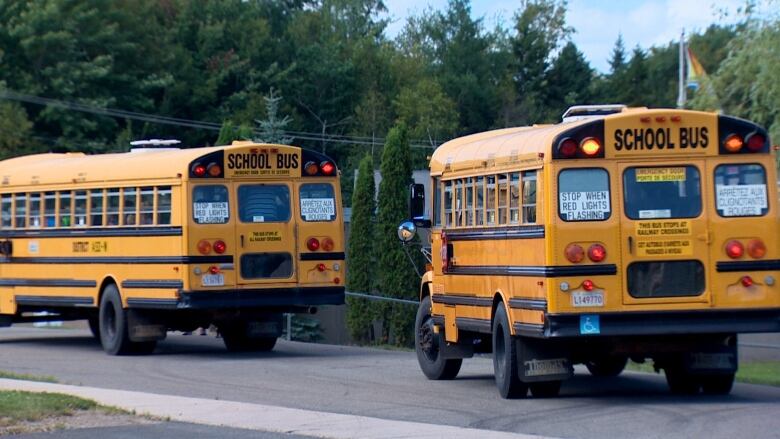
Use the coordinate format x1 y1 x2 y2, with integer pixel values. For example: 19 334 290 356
0 141 297 187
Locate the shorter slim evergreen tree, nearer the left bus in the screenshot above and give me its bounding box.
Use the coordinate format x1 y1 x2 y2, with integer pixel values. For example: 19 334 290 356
346 154 376 343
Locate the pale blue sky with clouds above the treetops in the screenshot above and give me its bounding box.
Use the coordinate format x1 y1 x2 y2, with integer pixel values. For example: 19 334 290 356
385 0 744 73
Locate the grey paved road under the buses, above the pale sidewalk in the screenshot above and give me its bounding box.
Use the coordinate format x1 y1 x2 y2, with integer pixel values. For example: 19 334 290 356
0 327 780 439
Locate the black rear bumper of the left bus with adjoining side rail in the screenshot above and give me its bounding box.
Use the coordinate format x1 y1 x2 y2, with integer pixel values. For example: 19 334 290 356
127 287 344 310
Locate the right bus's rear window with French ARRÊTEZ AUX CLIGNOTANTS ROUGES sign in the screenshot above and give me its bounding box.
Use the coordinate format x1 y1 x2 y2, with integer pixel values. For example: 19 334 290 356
715 164 769 217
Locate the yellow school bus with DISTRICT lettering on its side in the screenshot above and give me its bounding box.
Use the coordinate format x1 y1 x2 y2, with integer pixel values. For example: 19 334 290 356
0 142 344 354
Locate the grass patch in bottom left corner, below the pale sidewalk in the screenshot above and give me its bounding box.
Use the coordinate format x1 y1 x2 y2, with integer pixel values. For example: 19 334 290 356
0 390 97 427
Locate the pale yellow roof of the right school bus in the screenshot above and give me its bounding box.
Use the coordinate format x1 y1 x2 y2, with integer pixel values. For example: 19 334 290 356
430 105 716 175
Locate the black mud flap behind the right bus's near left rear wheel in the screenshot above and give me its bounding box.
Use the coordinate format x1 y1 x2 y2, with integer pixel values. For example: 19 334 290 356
514 337 574 383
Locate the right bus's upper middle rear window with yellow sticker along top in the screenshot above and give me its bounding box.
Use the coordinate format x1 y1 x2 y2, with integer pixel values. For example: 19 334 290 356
623 166 701 219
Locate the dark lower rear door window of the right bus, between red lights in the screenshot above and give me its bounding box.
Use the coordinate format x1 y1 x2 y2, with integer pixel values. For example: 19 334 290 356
628 261 704 299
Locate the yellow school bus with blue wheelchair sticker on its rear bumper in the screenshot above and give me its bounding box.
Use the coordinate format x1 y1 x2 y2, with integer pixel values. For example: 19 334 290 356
399 105 780 398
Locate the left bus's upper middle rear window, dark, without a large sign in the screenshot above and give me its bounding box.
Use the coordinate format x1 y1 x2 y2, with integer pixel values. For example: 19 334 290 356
238 184 290 223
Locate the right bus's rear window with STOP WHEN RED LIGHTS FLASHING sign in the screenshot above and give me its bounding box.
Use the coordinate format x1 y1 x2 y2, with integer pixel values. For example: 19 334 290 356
558 168 612 221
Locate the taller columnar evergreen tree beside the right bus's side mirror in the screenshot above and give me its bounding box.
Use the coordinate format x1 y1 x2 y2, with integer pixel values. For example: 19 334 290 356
375 123 420 346
